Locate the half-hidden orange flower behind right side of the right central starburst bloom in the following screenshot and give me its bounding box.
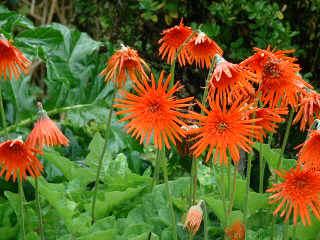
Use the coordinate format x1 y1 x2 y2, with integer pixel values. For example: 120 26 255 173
249 108 288 140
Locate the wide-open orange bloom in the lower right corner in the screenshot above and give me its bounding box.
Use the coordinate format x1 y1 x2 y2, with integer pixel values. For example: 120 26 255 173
267 167 320 226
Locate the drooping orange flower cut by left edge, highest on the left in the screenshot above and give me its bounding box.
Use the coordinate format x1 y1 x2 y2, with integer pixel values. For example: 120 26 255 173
0 35 31 81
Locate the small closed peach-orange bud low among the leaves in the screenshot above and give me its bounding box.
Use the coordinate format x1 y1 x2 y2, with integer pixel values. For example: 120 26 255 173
184 201 203 235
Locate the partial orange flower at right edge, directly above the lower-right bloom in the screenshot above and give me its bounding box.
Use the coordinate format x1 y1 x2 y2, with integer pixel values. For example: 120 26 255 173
296 130 320 170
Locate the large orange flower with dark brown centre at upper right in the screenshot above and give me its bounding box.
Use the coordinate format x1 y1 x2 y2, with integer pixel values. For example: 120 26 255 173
240 47 313 108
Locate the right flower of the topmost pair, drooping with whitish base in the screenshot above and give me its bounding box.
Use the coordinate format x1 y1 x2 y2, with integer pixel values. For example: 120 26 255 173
186 32 223 68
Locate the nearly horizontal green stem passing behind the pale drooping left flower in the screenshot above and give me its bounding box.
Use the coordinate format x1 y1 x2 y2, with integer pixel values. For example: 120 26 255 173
0 103 95 135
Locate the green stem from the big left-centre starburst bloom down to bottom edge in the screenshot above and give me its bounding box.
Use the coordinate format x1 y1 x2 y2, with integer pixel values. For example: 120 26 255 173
161 147 178 240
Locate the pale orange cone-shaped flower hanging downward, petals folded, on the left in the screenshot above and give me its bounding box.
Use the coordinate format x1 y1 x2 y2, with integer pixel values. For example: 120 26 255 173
26 103 69 149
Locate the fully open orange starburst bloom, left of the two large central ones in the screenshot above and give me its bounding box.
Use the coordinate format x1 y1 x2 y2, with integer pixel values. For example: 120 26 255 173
114 71 193 149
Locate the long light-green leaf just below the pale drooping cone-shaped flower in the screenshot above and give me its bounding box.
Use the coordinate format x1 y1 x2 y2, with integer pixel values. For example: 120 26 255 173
44 150 95 185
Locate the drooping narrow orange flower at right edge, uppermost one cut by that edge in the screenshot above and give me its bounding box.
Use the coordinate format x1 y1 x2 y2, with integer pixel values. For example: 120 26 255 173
293 91 320 131
